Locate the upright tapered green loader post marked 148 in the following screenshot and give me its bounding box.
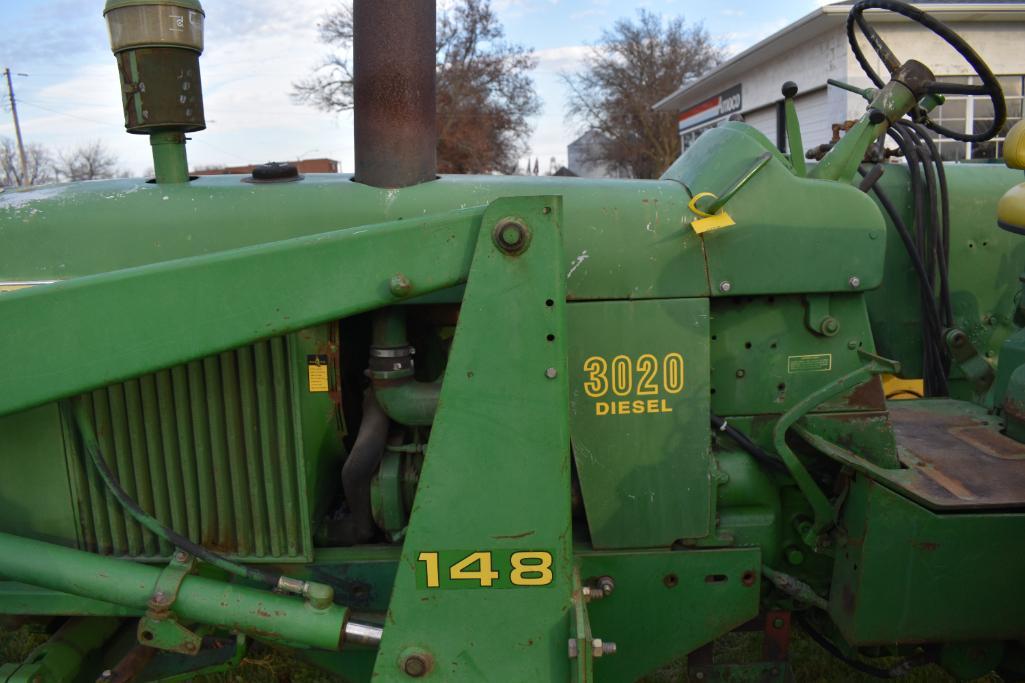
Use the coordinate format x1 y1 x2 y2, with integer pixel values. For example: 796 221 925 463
374 196 573 682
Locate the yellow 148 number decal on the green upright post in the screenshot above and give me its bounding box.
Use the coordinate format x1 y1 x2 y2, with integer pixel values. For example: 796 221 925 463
416 551 555 589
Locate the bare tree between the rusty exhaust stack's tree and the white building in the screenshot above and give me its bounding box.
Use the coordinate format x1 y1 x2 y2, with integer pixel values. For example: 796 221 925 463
563 9 725 177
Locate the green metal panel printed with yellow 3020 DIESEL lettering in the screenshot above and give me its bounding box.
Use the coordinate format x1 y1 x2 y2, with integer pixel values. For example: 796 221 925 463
567 298 713 549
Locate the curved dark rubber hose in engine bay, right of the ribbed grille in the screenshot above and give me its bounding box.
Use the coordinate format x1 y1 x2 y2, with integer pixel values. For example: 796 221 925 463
338 389 391 545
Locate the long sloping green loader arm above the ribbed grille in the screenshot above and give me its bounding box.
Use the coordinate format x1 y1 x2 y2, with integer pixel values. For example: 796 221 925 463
0 202 484 414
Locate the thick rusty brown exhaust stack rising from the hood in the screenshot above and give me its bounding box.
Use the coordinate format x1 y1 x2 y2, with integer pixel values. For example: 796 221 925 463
353 0 438 188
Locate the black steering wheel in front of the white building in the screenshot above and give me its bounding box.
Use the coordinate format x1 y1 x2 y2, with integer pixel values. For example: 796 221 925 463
847 0 1008 143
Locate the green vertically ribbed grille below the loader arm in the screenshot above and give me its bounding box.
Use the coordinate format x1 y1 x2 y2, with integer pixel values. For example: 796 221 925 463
69 337 312 561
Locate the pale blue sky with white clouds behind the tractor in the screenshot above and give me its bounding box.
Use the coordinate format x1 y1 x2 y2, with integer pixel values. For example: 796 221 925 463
0 0 820 174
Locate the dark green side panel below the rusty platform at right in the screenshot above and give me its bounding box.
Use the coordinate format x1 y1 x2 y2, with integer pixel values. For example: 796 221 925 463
829 476 1025 645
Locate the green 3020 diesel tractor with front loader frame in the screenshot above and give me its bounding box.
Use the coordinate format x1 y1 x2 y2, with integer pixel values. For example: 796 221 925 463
0 0 1025 683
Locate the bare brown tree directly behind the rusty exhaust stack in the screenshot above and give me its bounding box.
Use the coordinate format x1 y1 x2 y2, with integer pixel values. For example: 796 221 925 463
292 0 541 173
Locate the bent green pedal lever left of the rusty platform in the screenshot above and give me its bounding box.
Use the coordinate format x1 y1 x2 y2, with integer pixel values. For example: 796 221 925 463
772 351 900 549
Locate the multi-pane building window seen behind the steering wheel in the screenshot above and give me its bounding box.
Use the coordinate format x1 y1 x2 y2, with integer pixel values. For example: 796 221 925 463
930 75 1025 161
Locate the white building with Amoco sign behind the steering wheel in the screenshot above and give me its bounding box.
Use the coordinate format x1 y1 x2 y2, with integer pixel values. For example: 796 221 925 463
654 2 1025 160
